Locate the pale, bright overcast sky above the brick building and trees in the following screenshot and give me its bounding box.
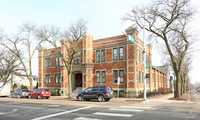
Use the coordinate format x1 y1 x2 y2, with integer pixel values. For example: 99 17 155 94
0 0 200 82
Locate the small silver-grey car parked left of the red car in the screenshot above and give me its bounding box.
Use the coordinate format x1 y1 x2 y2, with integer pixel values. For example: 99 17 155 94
11 89 29 98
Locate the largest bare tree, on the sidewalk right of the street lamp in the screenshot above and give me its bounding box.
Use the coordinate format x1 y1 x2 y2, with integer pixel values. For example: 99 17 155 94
124 0 194 98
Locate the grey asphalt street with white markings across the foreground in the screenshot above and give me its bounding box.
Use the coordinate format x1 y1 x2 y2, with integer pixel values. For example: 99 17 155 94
0 92 200 120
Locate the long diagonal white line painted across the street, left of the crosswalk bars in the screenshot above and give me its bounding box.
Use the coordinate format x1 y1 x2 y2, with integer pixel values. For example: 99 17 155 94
32 106 92 120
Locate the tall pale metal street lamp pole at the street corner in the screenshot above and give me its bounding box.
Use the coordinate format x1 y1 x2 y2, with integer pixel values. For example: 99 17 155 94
132 10 147 101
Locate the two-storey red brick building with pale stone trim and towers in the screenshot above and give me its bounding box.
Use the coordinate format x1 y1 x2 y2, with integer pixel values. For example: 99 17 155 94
38 27 170 97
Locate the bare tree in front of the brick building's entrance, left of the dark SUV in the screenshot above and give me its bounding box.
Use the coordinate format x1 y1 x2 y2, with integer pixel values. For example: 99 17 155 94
37 20 87 98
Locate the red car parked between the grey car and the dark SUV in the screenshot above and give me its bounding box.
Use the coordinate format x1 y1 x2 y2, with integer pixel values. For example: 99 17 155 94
28 88 51 99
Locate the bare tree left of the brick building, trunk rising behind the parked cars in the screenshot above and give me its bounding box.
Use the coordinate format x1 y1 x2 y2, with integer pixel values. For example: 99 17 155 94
0 23 43 91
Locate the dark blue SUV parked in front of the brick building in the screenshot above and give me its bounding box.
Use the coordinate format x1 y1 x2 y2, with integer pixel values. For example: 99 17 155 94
76 86 113 102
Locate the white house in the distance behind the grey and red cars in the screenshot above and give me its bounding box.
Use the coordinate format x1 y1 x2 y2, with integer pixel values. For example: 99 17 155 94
13 73 38 90
